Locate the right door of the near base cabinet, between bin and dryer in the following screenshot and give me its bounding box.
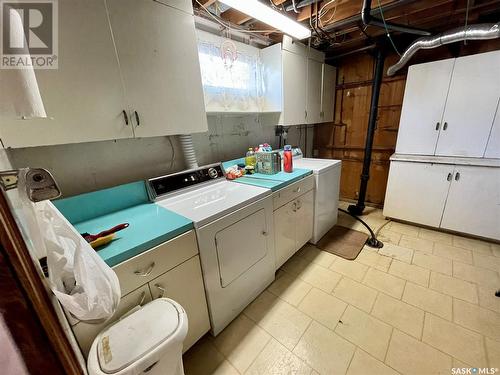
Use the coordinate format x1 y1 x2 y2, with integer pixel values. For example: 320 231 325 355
149 256 210 351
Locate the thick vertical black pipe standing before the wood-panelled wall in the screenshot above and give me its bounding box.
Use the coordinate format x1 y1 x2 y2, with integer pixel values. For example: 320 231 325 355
348 47 385 215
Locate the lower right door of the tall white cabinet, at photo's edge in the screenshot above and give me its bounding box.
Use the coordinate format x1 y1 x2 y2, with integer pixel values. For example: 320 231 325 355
441 165 500 239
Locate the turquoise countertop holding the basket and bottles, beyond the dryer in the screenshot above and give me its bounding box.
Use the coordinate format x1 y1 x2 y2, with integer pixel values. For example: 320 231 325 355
222 159 312 191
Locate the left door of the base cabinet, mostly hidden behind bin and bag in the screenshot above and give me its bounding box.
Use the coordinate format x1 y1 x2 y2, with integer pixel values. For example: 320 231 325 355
72 284 152 358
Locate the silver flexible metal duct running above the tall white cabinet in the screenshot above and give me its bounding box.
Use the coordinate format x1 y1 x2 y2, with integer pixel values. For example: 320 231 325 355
387 22 500 76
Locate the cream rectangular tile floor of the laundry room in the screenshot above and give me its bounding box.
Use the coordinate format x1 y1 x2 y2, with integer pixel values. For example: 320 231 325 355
184 202 500 375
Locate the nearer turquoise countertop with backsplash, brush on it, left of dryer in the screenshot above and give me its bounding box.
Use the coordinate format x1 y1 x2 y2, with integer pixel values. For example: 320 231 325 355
53 181 193 266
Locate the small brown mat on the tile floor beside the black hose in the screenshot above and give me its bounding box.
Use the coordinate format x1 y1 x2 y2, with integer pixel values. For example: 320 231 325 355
316 225 368 260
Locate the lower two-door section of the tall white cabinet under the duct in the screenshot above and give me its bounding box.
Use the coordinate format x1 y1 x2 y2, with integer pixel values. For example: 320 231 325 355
384 160 500 240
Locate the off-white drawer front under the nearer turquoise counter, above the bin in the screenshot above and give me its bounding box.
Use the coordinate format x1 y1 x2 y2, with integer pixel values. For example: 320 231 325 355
113 230 198 295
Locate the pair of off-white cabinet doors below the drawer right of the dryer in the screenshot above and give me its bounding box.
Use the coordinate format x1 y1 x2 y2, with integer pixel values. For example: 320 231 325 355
274 182 314 269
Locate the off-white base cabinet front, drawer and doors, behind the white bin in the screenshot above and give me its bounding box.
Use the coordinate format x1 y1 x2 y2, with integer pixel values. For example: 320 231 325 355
69 231 210 357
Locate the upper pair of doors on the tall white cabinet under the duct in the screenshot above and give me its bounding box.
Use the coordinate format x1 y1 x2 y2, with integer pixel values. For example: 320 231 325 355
396 51 500 157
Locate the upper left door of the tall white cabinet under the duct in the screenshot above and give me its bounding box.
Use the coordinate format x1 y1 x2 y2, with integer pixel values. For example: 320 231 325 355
396 59 455 155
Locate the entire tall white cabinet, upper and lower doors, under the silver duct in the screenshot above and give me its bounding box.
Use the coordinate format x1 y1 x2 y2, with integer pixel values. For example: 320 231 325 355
384 51 500 240
